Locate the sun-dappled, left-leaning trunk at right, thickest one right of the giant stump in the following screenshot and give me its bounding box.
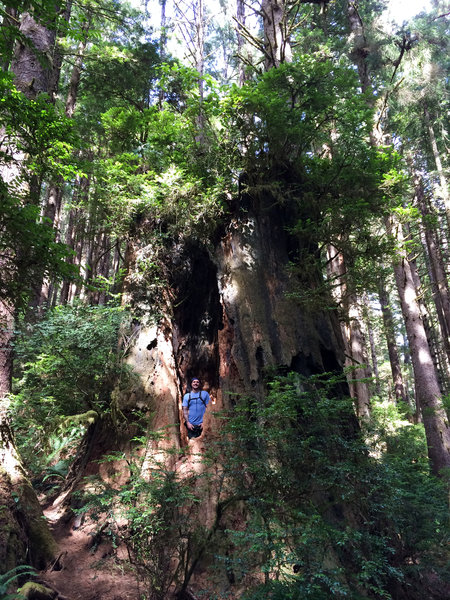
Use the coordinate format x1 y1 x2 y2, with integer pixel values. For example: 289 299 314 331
386 213 450 475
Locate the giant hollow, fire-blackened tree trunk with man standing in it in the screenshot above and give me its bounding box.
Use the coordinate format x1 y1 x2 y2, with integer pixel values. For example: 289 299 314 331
113 192 348 460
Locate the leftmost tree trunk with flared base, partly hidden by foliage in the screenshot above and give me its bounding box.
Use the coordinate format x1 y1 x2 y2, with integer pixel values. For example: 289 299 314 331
0 5 56 568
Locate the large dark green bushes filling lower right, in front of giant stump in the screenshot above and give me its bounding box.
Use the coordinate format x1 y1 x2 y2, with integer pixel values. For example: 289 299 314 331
208 374 448 600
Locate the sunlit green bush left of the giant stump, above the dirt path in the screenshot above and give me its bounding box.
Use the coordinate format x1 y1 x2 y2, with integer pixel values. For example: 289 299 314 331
10 304 133 474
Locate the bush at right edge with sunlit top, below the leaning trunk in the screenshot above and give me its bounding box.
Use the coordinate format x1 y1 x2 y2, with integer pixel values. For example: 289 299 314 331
374 404 450 578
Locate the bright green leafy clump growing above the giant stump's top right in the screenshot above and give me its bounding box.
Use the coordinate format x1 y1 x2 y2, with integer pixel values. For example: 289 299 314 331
223 54 372 177
